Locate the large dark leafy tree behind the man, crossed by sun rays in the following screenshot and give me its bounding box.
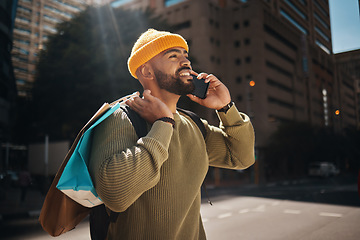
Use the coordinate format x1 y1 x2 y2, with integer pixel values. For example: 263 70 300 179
32 6 170 140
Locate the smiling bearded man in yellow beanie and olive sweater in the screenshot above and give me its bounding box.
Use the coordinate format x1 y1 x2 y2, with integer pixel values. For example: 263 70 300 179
90 29 254 240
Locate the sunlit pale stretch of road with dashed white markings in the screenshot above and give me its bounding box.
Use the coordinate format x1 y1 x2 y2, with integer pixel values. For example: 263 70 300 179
202 197 360 240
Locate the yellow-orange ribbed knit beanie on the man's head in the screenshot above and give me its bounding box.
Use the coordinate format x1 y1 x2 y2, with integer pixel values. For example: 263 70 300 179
128 29 189 79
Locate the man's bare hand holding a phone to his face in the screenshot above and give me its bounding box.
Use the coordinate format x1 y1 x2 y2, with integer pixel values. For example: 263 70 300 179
187 71 231 110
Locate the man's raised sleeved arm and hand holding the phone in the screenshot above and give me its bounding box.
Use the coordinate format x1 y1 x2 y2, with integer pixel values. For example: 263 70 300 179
188 71 255 169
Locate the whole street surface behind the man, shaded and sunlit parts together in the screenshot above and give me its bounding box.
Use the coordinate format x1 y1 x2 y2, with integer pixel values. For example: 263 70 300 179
0 174 360 240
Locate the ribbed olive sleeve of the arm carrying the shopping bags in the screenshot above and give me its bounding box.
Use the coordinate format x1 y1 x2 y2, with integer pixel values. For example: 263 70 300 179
90 109 173 212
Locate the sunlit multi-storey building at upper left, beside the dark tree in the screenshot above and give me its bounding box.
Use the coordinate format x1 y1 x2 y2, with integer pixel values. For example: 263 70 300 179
12 0 87 98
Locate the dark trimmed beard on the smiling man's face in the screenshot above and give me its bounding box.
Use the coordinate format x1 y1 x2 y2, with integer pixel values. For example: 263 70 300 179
154 68 195 96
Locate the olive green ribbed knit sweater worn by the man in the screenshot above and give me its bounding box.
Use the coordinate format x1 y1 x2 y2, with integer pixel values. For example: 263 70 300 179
90 106 254 240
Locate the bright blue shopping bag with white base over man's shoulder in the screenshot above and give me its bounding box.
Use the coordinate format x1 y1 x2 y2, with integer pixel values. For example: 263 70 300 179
56 103 120 207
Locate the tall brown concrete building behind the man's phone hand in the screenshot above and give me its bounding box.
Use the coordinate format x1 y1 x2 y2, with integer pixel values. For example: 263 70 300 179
112 0 336 148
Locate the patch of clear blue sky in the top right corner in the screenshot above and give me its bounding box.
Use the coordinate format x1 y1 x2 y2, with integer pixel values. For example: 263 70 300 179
329 0 360 53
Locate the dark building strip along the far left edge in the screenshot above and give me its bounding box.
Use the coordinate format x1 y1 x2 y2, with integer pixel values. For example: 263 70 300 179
0 0 17 167
